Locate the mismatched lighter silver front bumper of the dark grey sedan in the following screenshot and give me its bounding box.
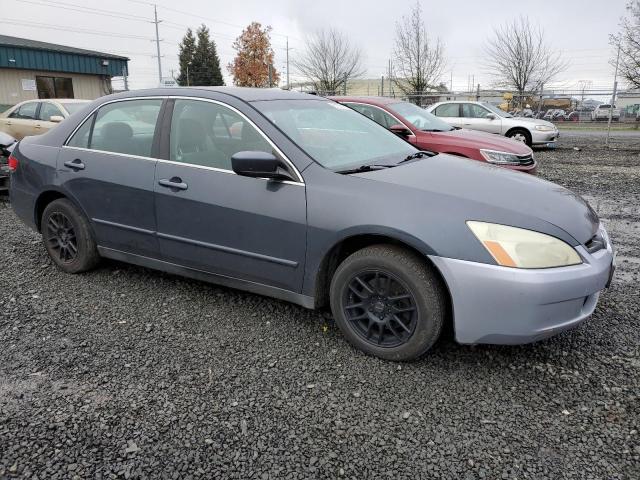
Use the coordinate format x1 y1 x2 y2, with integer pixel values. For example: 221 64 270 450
429 233 614 345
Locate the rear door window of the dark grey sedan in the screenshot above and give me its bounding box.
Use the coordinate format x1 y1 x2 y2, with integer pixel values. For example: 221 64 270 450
68 99 162 157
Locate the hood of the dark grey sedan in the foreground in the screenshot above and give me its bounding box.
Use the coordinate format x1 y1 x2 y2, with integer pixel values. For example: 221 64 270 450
357 154 599 246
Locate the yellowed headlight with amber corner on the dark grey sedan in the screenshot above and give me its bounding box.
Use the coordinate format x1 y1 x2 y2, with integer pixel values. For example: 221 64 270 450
467 221 582 268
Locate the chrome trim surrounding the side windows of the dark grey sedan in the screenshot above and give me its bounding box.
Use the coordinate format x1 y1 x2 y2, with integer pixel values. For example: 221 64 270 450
62 95 304 185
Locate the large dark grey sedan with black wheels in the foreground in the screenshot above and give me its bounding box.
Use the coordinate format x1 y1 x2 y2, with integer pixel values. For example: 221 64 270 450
9 87 613 360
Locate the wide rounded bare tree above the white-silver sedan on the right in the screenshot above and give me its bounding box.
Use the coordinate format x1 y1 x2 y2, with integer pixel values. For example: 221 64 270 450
485 17 568 101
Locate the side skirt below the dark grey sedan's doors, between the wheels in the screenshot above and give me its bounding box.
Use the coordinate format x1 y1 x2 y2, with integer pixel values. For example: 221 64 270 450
98 246 315 309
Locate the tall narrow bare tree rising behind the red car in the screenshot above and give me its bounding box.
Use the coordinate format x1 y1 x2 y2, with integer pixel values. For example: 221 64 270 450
393 2 445 103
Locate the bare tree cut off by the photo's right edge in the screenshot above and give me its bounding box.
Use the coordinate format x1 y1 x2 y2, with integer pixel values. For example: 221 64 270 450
611 0 640 88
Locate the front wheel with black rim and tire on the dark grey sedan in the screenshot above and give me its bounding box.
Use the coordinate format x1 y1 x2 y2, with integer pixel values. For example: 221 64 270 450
330 245 447 361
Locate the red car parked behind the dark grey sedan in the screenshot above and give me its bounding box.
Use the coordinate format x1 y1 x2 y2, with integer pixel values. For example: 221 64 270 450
330 97 537 173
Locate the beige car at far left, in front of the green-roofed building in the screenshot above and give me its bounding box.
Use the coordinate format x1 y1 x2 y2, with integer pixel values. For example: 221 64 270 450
0 98 89 140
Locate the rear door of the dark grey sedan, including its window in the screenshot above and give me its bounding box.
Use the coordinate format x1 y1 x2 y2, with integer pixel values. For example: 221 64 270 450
58 98 163 257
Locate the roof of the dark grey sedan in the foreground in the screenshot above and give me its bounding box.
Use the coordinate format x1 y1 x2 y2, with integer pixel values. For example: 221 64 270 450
118 87 324 102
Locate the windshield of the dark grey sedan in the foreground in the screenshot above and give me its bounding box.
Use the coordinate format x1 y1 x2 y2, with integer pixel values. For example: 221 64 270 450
252 100 417 171
